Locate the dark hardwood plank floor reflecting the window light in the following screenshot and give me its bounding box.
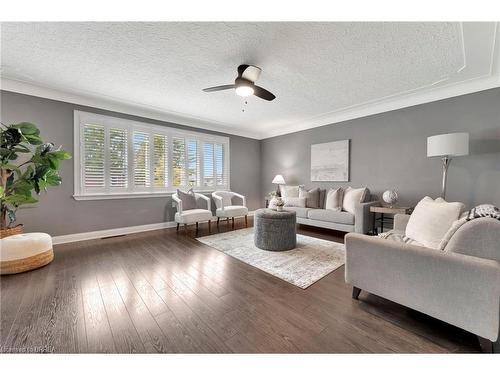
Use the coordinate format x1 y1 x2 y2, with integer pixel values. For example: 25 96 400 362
0 220 479 353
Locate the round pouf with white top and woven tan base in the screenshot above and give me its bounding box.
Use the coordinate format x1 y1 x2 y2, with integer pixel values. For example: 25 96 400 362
0 233 54 275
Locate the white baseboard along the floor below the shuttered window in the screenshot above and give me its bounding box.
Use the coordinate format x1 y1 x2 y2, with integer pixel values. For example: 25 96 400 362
52 211 255 245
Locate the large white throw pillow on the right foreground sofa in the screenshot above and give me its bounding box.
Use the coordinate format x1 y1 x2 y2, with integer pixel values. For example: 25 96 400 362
406 197 464 249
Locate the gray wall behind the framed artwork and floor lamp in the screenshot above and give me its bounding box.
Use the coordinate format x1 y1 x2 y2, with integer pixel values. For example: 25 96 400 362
261 89 500 207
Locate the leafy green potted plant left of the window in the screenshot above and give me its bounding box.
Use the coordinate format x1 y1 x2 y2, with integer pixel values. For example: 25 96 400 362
0 122 71 238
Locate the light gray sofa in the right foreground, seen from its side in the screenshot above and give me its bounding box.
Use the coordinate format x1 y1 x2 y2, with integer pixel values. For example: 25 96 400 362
345 215 500 353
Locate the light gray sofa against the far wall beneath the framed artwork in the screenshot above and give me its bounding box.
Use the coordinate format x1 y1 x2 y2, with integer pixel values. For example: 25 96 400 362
283 193 380 233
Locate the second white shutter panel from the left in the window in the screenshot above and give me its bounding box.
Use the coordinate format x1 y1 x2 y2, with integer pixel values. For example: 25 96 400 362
109 128 128 188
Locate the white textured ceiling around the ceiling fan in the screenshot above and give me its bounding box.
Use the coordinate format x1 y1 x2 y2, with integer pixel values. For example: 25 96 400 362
1 22 500 138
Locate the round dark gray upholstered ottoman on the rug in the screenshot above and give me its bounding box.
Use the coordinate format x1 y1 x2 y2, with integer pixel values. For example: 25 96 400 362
253 208 297 251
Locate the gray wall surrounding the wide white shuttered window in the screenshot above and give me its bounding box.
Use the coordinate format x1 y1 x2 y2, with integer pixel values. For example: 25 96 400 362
0 91 262 235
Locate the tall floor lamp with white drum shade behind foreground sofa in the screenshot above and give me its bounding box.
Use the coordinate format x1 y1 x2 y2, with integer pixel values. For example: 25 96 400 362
427 133 469 199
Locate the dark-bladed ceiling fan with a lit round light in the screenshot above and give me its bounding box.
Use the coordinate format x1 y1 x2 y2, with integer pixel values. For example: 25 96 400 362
203 65 276 101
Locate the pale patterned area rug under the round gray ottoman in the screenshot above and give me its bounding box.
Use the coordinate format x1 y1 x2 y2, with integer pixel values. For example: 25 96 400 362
198 228 345 289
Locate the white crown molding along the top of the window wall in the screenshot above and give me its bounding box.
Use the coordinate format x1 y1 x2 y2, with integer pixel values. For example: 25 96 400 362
0 77 262 139
